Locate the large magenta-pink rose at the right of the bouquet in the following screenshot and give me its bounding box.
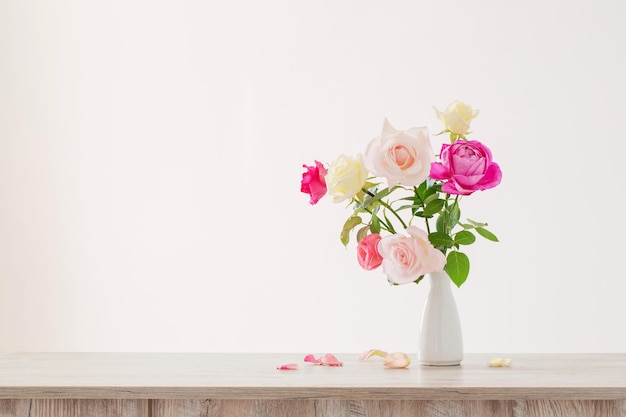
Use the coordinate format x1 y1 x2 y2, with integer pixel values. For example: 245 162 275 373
430 140 502 195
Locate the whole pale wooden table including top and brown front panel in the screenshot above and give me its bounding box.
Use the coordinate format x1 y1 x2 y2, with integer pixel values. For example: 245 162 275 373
0 352 626 417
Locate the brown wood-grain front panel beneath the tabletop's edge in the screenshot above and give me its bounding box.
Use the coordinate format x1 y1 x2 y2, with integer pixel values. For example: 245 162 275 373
0 399 626 417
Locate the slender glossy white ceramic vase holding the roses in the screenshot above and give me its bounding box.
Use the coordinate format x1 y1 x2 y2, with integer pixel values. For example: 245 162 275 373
418 271 463 366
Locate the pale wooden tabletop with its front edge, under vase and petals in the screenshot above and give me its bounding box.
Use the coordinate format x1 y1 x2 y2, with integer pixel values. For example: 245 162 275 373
0 353 626 400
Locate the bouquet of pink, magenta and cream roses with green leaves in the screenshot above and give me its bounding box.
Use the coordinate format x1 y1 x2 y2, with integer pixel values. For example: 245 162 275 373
300 101 502 287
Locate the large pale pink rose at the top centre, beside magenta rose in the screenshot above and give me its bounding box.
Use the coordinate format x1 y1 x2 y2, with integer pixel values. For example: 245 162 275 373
364 119 435 187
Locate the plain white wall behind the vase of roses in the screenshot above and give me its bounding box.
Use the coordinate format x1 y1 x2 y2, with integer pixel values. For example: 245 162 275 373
0 0 626 353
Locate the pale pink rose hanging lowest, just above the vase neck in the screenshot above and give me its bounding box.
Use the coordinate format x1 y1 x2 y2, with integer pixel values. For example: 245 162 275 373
378 226 446 284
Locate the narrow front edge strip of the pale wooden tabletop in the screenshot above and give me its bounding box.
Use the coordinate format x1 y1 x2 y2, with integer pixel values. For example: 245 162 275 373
0 386 626 400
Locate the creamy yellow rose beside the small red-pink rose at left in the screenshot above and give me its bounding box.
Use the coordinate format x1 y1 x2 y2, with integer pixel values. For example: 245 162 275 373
324 155 367 203
